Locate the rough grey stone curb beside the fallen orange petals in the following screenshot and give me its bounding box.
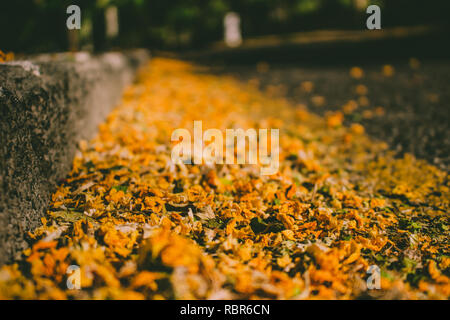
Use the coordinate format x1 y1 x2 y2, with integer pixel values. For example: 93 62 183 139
0 50 149 264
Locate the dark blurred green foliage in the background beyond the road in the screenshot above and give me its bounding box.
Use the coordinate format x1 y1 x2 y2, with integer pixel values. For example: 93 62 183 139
0 0 450 53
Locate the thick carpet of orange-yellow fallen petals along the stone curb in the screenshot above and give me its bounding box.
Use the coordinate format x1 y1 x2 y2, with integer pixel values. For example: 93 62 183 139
0 58 450 299
